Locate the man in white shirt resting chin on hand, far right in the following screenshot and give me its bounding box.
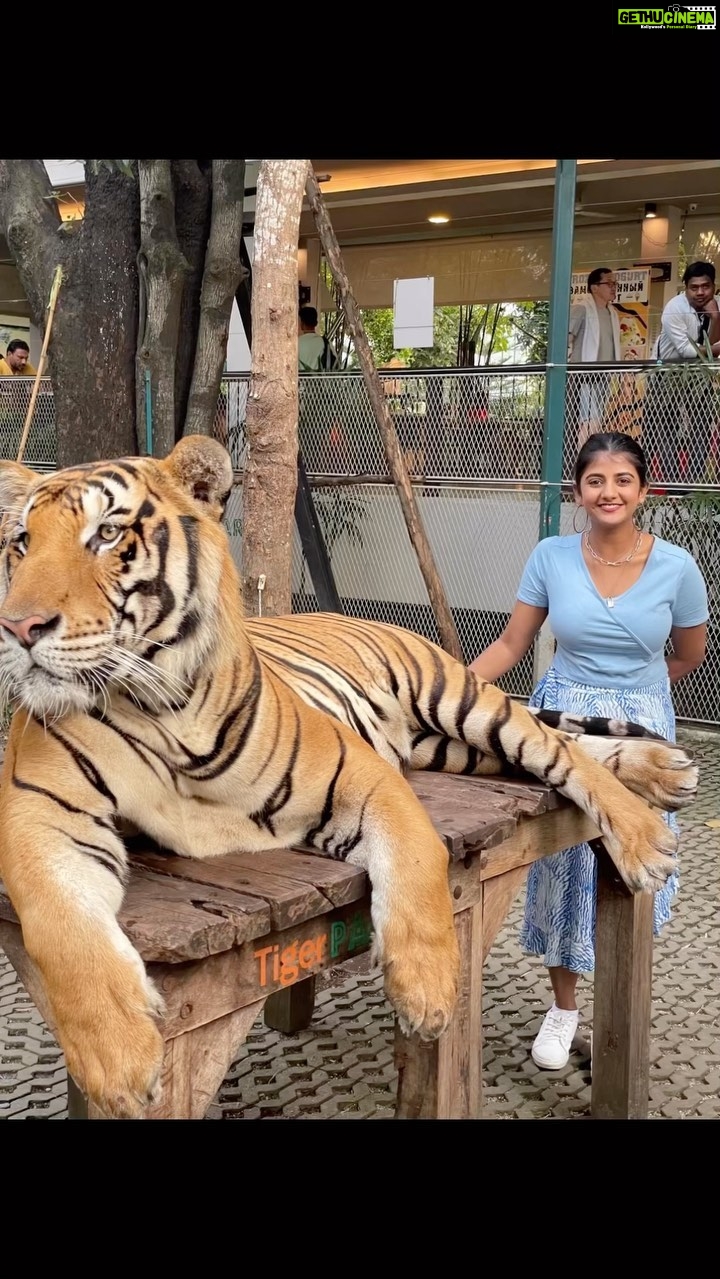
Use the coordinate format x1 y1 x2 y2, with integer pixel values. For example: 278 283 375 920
647 262 720 483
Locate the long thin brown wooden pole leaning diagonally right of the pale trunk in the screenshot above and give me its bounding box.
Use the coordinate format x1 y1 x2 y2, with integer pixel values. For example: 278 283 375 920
306 170 464 661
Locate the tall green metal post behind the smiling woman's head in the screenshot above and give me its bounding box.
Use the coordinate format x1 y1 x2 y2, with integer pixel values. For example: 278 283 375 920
540 160 577 538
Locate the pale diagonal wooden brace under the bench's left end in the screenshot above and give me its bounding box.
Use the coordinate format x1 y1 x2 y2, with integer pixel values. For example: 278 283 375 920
146 999 265 1119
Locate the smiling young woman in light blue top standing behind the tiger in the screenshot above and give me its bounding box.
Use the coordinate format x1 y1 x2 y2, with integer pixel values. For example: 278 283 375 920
471 434 707 1071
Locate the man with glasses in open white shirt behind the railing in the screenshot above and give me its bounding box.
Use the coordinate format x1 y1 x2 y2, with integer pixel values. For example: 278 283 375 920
568 266 622 448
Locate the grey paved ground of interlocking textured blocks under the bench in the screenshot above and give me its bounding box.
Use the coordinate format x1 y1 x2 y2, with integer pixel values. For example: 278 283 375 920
0 733 720 1119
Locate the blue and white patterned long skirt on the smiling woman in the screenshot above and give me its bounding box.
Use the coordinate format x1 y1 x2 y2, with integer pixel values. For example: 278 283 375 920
519 666 678 972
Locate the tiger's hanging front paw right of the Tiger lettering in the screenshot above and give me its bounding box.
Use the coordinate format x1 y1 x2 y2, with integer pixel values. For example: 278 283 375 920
382 923 460 1040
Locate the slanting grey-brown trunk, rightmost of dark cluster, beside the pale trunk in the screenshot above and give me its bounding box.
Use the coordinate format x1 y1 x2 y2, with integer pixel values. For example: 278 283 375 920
184 160 246 435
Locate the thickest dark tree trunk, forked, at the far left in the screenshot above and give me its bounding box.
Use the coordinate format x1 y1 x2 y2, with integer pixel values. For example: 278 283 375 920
0 160 139 466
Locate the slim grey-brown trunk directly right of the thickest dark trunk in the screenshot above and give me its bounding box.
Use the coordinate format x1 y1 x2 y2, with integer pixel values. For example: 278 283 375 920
136 160 189 458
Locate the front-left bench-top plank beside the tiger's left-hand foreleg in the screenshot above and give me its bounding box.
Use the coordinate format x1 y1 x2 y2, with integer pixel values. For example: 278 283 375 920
118 867 271 963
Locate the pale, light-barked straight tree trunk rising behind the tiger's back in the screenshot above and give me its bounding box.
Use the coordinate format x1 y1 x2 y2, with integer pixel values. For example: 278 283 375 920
243 160 309 616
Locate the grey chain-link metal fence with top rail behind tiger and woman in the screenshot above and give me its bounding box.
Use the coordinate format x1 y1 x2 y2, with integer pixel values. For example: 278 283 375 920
0 365 720 724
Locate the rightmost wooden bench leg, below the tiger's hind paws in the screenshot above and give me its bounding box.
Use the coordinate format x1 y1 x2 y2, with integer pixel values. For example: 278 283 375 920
591 840 652 1119
